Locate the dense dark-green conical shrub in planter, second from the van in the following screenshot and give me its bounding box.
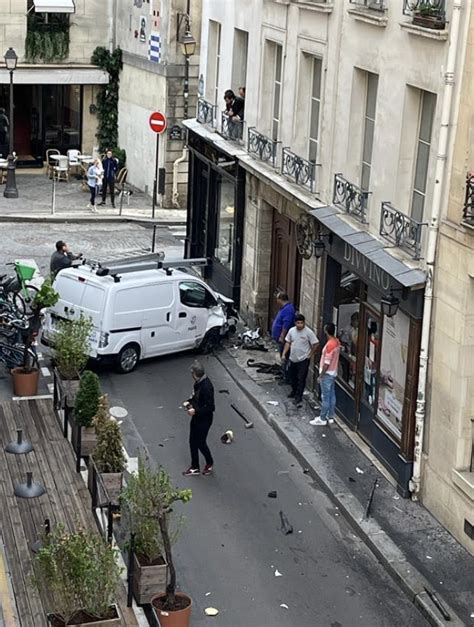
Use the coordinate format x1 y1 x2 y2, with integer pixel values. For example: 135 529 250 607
72 370 101 456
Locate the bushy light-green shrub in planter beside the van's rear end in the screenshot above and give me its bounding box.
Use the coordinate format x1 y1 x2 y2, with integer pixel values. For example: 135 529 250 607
54 314 94 407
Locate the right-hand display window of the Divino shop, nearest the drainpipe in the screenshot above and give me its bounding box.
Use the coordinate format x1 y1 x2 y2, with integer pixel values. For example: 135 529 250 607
377 310 410 438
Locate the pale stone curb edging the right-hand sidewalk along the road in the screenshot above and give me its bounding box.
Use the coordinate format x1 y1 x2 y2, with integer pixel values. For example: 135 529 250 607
215 351 465 627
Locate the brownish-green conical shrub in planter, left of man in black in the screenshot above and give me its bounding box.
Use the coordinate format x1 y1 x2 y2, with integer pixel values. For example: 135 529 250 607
89 394 127 505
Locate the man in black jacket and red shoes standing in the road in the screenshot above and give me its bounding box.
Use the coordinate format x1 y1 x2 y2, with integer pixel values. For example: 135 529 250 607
183 361 215 477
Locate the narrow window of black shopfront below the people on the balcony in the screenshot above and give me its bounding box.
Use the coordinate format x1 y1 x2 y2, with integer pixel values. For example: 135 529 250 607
214 178 235 272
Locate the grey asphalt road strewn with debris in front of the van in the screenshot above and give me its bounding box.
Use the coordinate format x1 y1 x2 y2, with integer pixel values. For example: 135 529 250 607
100 354 426 627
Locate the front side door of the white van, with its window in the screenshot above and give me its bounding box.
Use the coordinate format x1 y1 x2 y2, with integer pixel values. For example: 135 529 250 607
177 279 216 350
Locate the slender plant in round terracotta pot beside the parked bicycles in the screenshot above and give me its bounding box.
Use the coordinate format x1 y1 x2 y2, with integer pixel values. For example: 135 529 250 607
11 279 59 396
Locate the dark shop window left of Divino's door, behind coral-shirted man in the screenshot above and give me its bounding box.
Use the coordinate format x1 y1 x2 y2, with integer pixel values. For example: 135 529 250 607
334 270 365 392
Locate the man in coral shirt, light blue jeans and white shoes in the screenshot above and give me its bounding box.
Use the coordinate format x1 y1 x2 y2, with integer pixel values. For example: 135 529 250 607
309 322 341 427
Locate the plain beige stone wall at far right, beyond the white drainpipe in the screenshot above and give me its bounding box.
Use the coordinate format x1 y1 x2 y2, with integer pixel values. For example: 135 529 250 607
422 6 474 554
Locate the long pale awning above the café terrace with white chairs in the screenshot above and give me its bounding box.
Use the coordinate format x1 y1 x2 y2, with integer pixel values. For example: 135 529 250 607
0 65 109 85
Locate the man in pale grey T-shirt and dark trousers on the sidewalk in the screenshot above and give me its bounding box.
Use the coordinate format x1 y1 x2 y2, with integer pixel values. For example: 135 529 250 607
282 314 319 407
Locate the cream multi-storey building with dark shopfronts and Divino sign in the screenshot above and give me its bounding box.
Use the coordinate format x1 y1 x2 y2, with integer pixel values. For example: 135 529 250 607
186 0 473 541
